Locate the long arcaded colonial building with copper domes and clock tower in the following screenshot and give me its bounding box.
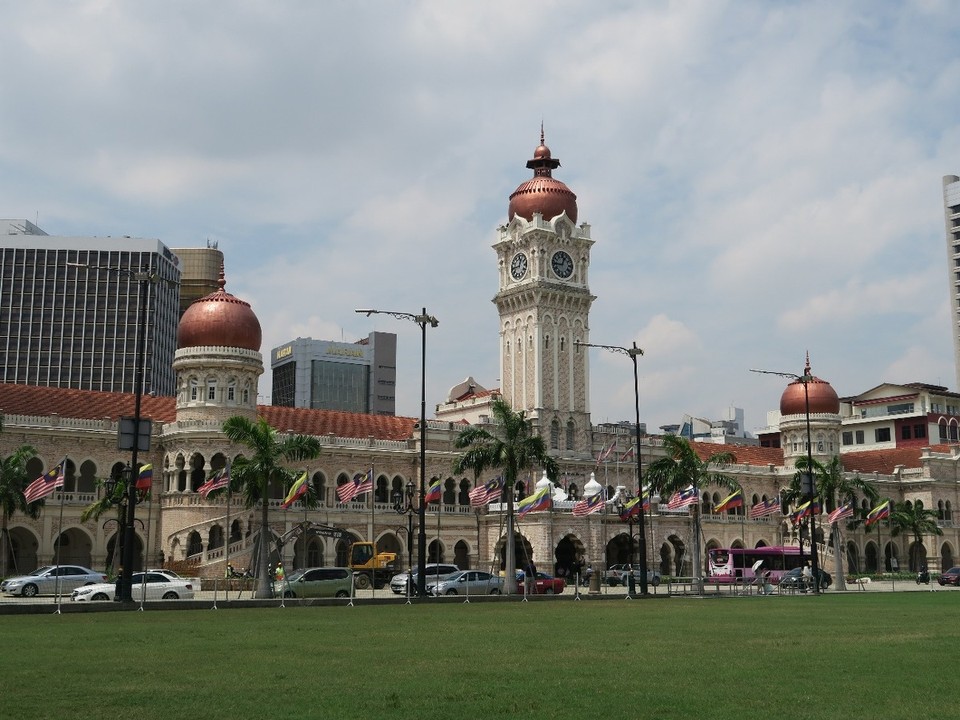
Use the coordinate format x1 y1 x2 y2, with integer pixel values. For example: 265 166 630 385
0 145 960 576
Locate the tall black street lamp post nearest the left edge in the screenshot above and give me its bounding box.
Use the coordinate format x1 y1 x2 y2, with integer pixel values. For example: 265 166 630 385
67 263 159 602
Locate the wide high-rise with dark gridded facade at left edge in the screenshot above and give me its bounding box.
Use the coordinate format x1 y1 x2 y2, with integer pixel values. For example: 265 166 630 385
0 220 180 395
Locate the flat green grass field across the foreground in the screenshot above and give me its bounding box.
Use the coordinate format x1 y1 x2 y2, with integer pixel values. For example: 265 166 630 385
0 593 960 720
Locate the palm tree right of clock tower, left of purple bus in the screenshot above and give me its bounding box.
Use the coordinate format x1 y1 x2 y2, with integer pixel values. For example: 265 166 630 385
647 435 741 592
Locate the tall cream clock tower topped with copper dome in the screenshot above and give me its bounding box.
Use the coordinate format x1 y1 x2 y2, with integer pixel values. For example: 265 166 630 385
493 134 595 453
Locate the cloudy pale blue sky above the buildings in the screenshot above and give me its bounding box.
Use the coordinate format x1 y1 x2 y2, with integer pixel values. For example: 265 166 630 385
0 0 960 431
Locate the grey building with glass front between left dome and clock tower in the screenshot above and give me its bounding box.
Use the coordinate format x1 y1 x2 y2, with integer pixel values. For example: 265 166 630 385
270 332 397 415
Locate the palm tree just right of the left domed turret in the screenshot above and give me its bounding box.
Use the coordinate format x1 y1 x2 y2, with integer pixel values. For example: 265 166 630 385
223 415 320 598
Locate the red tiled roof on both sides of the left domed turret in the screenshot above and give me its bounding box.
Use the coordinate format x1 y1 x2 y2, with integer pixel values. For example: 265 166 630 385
0 383 419 440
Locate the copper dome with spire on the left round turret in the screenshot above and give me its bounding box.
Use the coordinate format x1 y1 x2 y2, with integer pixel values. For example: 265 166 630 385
177 269 263 352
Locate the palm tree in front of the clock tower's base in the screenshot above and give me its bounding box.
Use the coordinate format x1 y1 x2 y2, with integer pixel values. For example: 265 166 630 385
453 398 560 595
